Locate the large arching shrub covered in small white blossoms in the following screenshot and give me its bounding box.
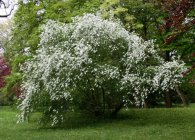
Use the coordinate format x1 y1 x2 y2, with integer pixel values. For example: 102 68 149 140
19 14 185 125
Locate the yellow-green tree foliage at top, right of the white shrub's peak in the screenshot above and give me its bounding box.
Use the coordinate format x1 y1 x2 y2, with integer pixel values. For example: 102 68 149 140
100 0 163 40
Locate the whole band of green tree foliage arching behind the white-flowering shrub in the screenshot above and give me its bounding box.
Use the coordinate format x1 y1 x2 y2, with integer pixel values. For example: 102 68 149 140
3 0 191 109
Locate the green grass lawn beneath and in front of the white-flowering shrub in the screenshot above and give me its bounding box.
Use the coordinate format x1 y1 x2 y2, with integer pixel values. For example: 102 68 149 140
0 106 195 140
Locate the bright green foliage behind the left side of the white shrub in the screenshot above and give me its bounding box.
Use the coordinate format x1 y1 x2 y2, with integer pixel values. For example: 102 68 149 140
3 0 101 97
